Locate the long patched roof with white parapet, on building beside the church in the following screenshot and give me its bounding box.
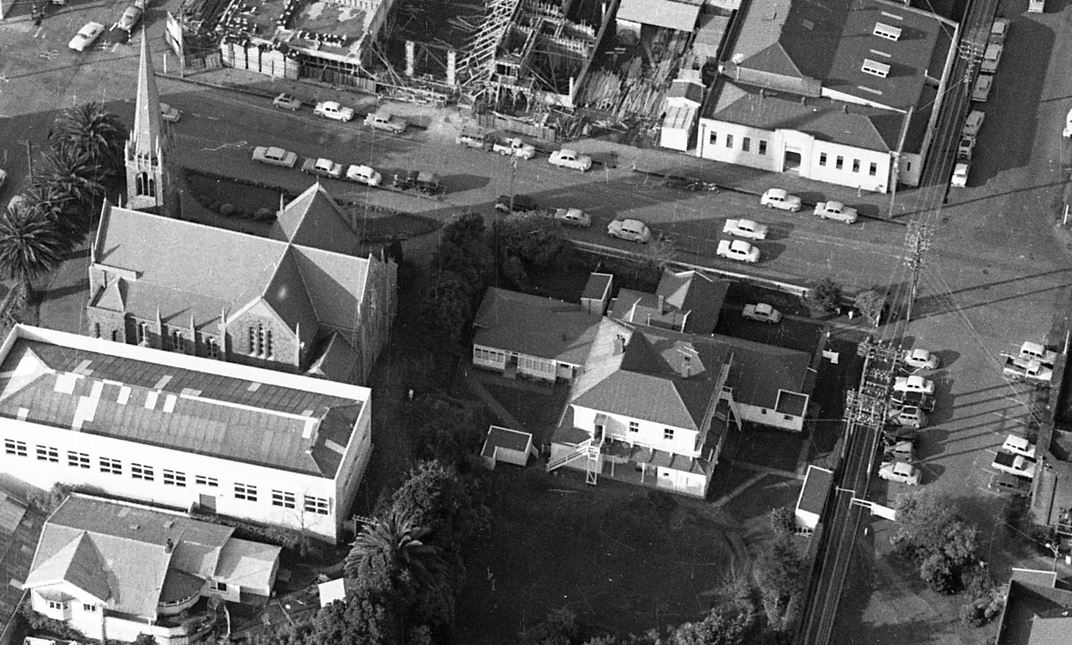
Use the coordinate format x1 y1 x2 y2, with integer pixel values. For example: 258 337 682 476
0 327 368 479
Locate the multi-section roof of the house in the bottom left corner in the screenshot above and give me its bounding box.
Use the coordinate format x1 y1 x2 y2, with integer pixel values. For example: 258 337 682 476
23 494 280 619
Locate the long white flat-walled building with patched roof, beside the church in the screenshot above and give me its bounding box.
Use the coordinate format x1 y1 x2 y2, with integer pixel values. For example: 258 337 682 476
0 326 372 542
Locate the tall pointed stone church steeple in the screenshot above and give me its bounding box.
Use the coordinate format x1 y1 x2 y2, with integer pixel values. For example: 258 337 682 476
125 28 179 216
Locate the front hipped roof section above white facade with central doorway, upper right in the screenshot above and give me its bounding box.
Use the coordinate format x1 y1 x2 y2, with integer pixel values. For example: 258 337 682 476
705 79 908 152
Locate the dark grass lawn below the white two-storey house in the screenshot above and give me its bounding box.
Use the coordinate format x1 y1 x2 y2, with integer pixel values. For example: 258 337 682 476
456 466 746 645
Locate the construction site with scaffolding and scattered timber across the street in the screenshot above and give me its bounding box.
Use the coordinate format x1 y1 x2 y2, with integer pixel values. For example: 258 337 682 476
182 0 736 144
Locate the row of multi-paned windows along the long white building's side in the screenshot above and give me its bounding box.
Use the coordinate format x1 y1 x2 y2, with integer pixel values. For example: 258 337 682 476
3 439 329 515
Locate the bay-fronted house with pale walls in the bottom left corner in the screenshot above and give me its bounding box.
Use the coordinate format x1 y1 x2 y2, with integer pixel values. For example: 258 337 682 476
21 494 281 645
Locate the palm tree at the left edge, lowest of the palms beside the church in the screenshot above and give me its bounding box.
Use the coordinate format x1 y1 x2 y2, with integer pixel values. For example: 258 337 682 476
0 205 68 302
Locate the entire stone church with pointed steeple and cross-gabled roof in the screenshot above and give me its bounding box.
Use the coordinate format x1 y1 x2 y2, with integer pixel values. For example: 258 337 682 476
83 28 397 384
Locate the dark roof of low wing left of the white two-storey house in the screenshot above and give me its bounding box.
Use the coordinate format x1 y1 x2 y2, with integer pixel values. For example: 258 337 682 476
473 287 600 365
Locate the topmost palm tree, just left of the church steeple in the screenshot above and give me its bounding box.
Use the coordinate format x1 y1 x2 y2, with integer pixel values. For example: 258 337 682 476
50 102 128 188
